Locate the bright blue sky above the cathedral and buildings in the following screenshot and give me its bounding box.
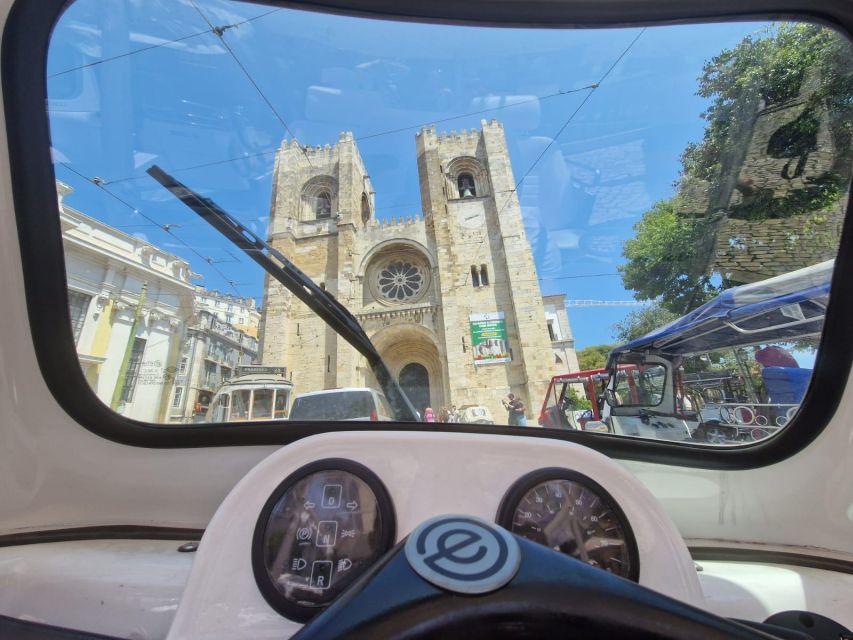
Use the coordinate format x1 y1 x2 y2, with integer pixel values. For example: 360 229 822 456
48 0 763 347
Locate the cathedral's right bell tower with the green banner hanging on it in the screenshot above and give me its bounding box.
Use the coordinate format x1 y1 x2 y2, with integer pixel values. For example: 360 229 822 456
417 120 554 422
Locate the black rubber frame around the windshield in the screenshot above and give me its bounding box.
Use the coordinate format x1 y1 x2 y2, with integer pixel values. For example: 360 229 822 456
2 0 853 469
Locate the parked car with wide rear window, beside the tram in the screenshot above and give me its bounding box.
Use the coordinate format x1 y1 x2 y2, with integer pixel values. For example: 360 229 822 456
290 387 393 422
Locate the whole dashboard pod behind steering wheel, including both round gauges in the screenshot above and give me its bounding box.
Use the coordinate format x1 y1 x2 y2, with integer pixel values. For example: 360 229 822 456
163 432 703 639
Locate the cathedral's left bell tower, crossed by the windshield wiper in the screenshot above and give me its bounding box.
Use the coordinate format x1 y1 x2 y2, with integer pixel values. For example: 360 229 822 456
260 132 374 390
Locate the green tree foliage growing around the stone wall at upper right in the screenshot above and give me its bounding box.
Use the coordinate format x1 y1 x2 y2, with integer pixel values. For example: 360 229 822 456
619 24 853 315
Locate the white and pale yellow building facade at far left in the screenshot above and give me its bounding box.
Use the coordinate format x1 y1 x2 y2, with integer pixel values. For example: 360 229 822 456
57 182 194 422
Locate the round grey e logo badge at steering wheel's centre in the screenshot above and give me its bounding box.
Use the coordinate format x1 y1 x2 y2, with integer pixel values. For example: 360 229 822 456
405 516 521 593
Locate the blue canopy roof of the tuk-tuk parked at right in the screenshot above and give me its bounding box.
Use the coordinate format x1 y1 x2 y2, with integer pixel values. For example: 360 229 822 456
610 260 834 358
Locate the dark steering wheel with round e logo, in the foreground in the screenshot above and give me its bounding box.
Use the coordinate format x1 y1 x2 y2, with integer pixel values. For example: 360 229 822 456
294 516 774 640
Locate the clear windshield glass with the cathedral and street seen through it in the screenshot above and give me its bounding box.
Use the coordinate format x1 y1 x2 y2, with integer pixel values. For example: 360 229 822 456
47 0 853 446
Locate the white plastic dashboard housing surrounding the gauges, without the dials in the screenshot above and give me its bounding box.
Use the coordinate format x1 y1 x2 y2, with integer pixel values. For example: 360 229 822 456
163 432 704 640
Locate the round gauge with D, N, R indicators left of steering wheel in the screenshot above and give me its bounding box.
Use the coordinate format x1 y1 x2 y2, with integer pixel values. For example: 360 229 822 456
252 459 395 622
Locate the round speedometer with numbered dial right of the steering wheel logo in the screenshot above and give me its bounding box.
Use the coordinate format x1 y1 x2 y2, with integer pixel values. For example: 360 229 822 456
497 468 640 581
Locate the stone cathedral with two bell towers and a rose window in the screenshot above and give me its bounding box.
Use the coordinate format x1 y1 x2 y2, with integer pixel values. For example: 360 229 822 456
261 120 570 424
